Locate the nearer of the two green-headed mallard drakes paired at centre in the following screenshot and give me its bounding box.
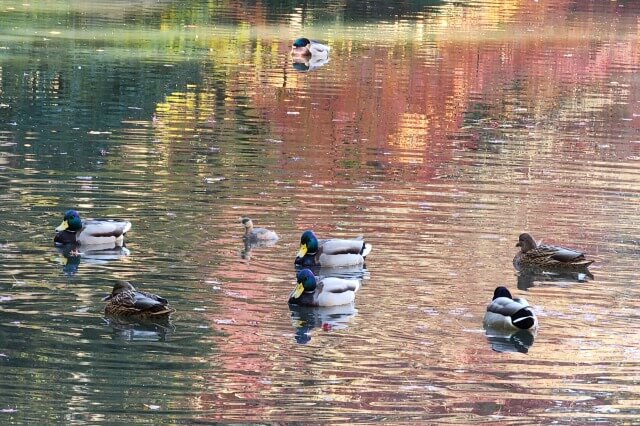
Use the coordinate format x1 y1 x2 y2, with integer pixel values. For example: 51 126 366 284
289 269 360 306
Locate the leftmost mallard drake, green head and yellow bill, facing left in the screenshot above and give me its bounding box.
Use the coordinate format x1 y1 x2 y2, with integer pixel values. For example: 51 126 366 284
53 210 131 246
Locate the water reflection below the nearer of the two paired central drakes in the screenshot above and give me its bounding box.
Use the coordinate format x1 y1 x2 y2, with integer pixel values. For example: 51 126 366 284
289 303 358 345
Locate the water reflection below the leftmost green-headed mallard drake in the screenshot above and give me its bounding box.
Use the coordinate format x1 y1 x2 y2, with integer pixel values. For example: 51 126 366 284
56 243 131 275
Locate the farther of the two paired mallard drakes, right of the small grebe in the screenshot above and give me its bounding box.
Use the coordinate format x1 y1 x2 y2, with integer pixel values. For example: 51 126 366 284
294 231 373 268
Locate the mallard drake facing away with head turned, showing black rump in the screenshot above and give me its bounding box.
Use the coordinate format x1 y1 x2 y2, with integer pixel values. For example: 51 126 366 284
483 287 538 330
